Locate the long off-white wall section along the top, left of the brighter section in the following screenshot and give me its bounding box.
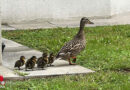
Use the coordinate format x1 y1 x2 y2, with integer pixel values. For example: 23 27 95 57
0 0 110 23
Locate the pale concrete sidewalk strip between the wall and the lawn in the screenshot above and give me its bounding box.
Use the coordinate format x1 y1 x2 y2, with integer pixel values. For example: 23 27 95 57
2 13 130 30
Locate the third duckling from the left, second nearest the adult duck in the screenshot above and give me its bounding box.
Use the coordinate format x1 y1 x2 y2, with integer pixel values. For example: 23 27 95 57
37 53 48 69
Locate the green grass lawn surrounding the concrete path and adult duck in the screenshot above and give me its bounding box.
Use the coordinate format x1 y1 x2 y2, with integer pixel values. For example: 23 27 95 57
2 25 130 90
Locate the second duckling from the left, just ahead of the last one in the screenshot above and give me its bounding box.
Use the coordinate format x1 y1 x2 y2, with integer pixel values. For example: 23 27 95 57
25 56 37 71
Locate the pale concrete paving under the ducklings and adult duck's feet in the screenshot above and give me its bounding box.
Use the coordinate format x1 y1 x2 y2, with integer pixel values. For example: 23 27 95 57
0 38 94 80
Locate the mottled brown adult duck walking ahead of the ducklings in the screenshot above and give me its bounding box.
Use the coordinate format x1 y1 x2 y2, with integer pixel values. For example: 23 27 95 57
56 17 93 65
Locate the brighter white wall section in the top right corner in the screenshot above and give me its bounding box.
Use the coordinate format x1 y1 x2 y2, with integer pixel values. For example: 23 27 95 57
111 0 130 15
